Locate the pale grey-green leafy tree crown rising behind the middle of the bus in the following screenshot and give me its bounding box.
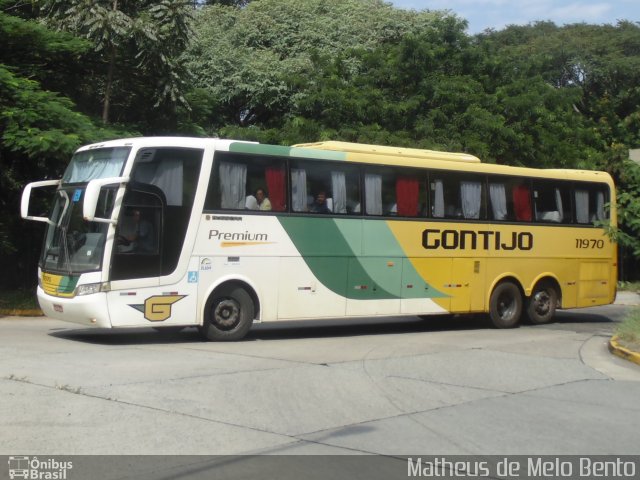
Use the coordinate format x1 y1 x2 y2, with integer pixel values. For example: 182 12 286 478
187 0 456 133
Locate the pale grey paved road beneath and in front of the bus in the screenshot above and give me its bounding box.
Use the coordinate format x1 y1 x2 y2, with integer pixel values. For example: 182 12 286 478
0 305 640 466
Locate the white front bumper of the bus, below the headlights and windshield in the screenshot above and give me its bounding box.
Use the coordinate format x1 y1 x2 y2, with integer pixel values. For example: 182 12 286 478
38 287 111 328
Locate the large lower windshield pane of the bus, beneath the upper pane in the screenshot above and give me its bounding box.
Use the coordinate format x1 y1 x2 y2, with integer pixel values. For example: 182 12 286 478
40 188 116 274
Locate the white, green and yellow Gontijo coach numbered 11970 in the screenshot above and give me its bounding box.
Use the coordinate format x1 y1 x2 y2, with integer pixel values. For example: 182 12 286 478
21 137 617 340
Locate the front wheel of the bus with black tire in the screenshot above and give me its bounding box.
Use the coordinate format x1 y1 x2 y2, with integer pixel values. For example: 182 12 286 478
200 287 255 341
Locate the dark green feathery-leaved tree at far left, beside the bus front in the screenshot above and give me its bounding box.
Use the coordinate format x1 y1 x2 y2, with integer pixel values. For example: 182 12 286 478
0 2 124 288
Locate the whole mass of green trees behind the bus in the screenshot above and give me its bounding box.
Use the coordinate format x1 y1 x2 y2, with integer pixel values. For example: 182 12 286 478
0 0 640 289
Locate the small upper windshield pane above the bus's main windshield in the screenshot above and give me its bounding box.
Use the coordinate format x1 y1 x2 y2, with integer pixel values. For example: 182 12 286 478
62 147 131 183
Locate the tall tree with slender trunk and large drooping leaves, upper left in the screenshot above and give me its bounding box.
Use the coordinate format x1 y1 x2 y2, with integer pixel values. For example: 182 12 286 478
42 0 192 124
